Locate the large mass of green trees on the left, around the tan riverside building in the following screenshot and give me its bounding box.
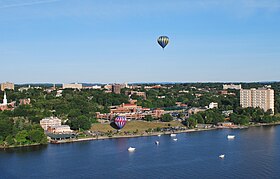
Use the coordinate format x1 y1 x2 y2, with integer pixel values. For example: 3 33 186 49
0 89 128 146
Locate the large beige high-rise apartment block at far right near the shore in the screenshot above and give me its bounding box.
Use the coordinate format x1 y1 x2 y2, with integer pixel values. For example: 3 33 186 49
240 88 274 114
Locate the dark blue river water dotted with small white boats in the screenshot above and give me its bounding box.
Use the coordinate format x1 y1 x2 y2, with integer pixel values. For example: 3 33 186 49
0 126 280 179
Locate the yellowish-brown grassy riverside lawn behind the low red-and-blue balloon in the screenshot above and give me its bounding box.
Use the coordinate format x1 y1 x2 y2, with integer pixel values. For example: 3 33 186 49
91 121 184 133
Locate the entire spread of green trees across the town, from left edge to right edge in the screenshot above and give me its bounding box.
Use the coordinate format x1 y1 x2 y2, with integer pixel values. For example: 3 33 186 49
0 82 280 146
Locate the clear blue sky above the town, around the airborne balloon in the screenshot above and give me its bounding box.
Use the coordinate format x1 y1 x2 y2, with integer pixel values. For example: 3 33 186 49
0 0 280 83
